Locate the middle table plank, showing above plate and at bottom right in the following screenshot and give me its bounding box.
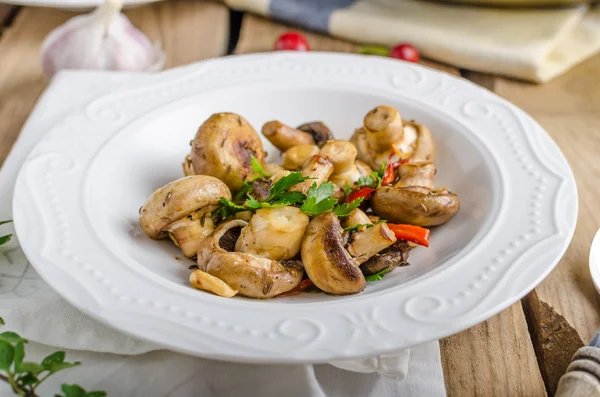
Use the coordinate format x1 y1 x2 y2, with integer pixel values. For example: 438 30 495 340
235 15 546 397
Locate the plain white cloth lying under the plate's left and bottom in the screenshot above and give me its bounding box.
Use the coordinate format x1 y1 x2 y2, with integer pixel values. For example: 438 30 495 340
0 71 445 397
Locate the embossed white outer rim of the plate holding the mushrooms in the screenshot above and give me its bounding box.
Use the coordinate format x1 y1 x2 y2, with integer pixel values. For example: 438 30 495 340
14 53 577 362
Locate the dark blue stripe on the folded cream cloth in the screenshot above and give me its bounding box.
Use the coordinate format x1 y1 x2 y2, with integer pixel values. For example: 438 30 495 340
269 0 356 33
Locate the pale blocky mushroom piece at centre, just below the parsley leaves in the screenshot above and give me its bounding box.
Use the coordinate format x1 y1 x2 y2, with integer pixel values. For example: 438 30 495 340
235 206 309 261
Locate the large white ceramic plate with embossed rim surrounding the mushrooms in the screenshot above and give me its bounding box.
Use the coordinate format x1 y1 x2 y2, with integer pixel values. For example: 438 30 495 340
14 53 577 362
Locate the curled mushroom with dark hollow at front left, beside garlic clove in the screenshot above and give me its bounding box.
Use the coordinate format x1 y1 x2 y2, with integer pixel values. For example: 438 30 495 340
197 220 304 298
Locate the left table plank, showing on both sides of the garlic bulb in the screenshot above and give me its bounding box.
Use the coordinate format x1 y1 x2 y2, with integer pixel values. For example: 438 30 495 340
0 0 229 162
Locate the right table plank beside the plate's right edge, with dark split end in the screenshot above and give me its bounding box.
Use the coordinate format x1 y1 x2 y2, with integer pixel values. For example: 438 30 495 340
495 55 600 392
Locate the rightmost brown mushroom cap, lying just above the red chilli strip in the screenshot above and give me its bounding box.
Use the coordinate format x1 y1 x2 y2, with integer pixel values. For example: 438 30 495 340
371 186 460 227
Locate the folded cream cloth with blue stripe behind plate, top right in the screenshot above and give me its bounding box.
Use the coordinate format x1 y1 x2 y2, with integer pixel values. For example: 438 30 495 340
225 0 600 82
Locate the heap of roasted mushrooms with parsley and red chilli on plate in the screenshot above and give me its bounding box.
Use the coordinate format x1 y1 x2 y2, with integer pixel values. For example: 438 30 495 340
140 106 460 298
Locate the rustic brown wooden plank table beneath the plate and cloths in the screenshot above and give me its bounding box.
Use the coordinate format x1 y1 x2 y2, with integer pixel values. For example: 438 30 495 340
0 0 600 397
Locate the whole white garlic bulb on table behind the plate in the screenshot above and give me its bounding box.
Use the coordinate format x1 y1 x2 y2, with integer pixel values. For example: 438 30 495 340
41 0 165 76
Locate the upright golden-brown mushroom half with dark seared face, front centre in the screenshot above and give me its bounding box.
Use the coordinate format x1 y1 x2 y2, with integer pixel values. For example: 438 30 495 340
301 212 366 295
